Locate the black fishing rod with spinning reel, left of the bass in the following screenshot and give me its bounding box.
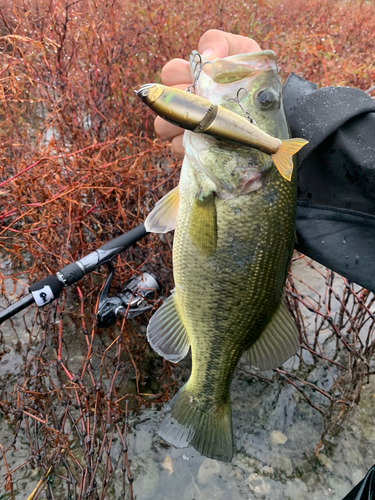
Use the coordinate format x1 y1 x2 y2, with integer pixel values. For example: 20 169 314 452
0 224 160 328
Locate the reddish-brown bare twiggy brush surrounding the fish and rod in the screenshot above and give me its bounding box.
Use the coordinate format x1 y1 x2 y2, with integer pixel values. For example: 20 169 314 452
0 0 375 499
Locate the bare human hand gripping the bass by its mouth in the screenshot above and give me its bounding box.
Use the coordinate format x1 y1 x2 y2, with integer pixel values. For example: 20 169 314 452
154 30 261 155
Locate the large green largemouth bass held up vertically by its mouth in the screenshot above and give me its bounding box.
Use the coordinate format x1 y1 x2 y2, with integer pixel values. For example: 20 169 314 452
140 51 299 461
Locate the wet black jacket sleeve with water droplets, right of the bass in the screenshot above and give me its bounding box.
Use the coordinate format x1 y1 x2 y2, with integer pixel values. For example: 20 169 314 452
284 74 375 292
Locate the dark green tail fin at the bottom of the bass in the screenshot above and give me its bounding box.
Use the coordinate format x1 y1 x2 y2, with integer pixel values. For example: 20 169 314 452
158 382 233 462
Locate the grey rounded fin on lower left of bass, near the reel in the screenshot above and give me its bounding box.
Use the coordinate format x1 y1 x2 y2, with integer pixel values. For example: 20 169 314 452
147 293 190 363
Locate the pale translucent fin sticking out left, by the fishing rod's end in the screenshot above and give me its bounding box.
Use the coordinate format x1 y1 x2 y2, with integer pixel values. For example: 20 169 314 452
145 186 179 233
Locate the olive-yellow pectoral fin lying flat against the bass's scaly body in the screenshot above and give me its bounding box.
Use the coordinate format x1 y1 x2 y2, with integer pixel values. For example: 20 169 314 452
189 193 217 257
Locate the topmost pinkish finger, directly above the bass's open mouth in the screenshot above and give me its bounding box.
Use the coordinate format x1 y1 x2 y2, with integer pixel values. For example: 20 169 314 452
198 30 261 61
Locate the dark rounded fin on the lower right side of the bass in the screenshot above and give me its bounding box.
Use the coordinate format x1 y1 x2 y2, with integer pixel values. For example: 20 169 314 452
244 302 300 370
